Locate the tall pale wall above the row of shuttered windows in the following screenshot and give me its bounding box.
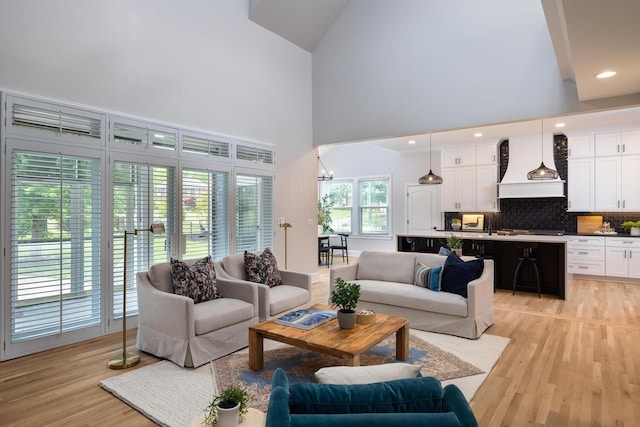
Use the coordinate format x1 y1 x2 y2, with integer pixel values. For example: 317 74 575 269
0 0 317 271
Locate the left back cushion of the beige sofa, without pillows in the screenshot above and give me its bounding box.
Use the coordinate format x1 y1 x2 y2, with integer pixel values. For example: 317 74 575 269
356 251 416 284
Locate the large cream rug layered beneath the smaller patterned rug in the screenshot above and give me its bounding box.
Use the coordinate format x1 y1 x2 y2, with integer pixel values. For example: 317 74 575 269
100 330 509 427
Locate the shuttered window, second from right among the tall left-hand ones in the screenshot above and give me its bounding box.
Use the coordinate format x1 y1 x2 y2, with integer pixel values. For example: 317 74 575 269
182 169 229 260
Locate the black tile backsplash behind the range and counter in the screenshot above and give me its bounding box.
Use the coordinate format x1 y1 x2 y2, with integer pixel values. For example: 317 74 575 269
445 135 640 233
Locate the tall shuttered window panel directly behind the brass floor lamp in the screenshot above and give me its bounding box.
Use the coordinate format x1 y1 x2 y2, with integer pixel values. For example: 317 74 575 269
113 161 175 318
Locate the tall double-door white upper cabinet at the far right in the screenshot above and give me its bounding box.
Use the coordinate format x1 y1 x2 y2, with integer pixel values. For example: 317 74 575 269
595 154 640 212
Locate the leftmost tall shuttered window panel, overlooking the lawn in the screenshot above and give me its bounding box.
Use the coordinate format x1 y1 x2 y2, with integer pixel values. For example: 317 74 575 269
10 151 102 342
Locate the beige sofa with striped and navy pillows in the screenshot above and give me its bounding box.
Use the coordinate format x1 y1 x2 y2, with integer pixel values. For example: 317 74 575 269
329 251 495 339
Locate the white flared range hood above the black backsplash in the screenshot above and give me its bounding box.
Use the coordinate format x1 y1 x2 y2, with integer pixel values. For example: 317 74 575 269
498 134 565 199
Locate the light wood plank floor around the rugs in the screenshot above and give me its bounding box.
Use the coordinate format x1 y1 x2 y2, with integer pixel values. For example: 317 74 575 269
0 258 640 427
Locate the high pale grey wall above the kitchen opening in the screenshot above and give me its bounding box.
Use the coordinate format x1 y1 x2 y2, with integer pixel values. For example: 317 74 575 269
313 0 638 145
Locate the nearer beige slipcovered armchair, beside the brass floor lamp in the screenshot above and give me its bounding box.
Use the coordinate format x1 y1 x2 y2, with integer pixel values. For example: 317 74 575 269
136 260 259 367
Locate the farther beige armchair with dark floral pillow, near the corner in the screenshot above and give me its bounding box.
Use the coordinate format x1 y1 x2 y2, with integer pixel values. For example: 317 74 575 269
215 252 311 321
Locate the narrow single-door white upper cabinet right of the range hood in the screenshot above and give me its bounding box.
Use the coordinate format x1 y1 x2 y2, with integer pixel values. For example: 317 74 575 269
567 156 595 212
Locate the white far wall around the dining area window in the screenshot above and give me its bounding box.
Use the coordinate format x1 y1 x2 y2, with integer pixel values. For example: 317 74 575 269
318 142 441 255
